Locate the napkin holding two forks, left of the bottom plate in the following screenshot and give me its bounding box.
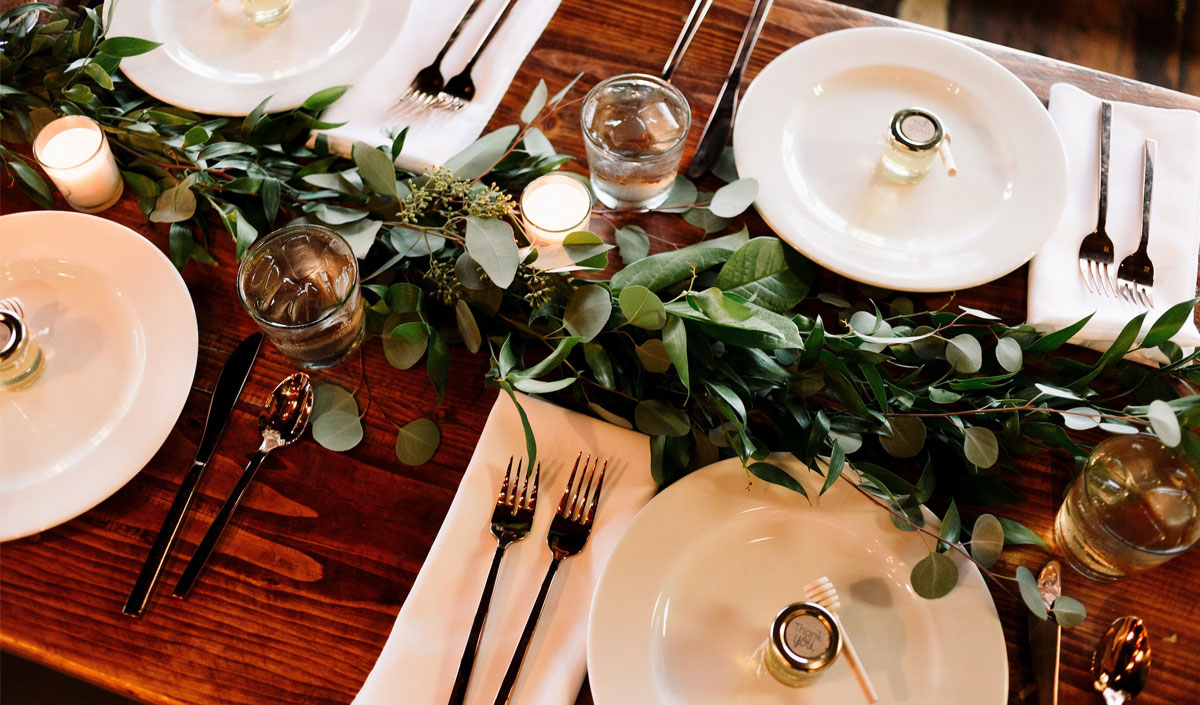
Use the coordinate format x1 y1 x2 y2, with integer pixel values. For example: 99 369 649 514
354 394 656 705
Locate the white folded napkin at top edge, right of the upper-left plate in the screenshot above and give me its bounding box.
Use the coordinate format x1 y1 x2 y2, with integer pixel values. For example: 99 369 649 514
322 0 559 171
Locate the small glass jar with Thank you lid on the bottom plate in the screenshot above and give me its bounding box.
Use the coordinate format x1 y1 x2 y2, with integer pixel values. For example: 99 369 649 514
763 602 841 688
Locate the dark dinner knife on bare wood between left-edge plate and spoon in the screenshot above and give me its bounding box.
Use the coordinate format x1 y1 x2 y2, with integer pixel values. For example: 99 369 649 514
121 333 263 617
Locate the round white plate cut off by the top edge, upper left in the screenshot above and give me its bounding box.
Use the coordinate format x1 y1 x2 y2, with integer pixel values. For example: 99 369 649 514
108 0 409 115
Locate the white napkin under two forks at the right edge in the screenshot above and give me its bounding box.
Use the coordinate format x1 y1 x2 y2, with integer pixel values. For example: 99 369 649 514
1028 83 1200 362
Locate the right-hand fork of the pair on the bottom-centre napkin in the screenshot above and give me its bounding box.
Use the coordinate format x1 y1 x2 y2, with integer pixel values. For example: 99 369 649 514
494 452 608 705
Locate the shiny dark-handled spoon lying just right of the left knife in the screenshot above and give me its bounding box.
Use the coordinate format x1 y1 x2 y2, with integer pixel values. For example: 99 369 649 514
174 372 312 598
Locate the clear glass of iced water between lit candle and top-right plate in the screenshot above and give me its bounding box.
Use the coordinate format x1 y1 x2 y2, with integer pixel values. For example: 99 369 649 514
580 73 691 209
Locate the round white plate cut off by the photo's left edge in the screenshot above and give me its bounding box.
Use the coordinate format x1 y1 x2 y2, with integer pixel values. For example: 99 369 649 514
0 211 198 541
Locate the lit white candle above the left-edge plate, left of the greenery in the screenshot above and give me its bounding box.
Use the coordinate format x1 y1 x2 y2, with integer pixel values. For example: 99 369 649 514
34 115 125 213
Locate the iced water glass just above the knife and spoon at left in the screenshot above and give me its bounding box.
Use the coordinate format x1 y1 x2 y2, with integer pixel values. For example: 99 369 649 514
238 224 366 369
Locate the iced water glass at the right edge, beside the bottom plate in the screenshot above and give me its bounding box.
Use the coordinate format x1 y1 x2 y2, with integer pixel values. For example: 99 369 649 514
1055 435 1200 582
